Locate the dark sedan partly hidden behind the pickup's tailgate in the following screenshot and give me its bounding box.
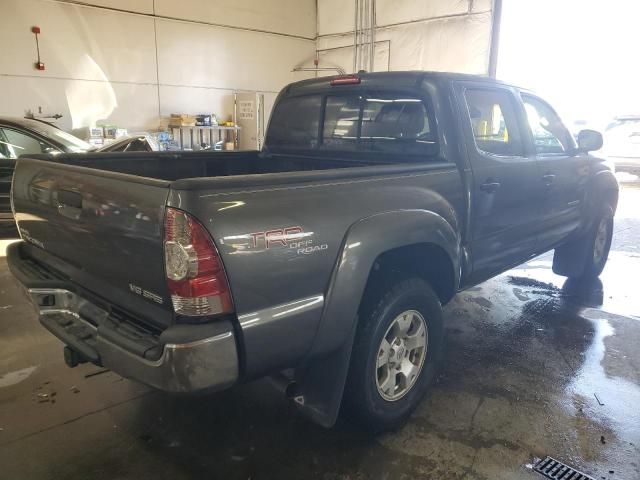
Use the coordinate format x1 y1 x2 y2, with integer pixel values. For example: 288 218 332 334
0 117 157 235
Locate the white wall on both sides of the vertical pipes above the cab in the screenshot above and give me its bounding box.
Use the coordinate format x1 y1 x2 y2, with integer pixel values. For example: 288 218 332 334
318 0 492 74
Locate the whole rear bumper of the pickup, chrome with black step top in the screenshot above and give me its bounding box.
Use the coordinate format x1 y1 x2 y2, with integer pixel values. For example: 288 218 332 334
7 242 239 392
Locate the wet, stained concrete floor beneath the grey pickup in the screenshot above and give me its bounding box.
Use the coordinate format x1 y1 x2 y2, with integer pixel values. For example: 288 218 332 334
0 184 640 480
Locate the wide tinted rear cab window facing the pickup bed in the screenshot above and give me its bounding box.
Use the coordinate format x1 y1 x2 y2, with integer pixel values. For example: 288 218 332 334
267 90 438 162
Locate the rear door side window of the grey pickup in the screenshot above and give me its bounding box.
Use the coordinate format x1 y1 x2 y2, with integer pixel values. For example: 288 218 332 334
465 88 524 156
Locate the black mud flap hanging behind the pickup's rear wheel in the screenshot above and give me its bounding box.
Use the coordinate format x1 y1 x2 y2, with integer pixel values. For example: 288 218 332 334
293 320 358 428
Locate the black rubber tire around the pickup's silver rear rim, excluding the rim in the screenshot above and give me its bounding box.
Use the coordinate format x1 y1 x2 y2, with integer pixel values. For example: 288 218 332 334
345 278 444 433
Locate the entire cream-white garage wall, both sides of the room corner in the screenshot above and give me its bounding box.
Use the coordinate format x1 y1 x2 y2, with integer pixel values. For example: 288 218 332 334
0 0 492 135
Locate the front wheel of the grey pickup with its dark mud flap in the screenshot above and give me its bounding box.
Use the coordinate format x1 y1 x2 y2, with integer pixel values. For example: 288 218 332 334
553 206 613 279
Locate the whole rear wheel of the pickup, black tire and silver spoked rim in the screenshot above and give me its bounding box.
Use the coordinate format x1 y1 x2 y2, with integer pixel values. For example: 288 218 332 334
345 278 443 431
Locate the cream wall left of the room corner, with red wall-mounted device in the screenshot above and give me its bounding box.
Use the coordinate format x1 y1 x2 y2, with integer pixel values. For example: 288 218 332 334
0 0 316 131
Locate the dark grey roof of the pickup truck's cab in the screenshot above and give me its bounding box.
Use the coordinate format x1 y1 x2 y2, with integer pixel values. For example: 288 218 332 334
283 70 508 95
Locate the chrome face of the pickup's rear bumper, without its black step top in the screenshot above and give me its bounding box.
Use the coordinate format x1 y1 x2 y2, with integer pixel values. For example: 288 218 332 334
26 288 239 392
